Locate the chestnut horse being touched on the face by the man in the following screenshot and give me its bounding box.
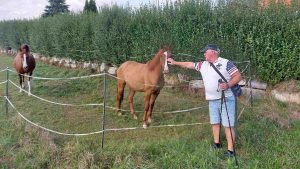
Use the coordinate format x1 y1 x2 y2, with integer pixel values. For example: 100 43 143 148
117 46 171 128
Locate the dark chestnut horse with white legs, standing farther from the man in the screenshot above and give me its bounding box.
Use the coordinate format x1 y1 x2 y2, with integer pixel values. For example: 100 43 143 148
14 44 35 95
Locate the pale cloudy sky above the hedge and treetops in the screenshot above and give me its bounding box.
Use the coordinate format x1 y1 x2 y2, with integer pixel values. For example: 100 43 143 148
0 0 164 21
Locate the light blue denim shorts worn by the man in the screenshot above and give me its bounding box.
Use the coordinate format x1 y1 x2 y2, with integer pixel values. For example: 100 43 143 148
209 96 236 127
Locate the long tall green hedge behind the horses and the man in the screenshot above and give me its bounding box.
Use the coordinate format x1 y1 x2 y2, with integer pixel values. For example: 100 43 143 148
0 0 300 83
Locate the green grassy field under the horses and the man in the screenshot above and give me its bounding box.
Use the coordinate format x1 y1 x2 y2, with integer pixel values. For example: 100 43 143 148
0 54 300 169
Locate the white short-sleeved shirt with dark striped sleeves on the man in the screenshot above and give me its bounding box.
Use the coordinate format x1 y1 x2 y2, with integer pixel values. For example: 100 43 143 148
194 57 238 100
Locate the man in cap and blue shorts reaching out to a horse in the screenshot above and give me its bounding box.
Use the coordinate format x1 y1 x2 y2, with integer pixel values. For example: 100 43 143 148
168 44 241 157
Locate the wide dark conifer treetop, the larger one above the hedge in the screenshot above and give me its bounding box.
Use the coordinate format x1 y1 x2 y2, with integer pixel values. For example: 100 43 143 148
42 0 70 17
